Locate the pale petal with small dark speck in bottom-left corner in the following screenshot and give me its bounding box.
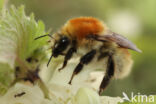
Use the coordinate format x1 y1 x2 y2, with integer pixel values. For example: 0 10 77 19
0 83 44 104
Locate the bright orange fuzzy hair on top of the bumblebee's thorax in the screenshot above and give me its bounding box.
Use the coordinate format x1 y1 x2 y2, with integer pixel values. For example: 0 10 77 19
62 17 105 40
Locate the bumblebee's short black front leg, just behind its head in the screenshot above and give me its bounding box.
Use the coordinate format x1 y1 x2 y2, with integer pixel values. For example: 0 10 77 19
59 47 76 71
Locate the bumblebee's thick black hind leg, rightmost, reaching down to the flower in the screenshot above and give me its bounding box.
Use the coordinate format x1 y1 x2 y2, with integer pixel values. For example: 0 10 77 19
99 55 115 94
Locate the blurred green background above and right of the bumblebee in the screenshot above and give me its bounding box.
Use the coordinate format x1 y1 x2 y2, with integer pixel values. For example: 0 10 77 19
8 0 156 96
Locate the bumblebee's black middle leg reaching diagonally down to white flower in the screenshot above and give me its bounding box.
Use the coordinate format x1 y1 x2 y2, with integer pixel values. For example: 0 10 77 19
69 50 96 84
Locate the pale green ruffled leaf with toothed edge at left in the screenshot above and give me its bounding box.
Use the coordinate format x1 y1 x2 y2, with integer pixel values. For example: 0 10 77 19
0 6 47 92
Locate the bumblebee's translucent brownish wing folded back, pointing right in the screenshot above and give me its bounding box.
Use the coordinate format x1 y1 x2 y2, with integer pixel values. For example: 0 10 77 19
95 32 142 52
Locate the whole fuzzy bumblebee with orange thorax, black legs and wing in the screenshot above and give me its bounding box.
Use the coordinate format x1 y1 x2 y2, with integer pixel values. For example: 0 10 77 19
36 17 141 94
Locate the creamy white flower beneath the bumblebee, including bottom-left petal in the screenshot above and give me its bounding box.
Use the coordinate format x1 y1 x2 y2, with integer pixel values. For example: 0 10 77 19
0 58 123 104
